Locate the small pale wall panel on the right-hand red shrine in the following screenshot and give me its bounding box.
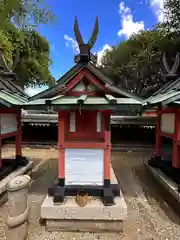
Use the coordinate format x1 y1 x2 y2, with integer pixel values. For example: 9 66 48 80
161 113 175 134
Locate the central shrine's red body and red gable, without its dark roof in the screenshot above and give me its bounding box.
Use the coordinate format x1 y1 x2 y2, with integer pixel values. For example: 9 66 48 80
49 67 123 204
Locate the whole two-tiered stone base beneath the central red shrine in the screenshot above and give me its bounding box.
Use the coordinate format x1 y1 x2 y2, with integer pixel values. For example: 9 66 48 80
41 168 127 232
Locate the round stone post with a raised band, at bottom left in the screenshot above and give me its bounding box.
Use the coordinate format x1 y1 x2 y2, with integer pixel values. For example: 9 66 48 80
7 175 31 240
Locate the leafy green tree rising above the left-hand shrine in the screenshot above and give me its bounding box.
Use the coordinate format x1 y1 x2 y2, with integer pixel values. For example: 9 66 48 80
0 0 55 87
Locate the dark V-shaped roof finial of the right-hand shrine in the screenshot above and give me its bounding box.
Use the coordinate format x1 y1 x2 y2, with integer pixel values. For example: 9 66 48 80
162 53 180 77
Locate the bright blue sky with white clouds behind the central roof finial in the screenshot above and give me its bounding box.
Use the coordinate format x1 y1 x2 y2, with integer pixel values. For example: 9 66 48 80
28 0 163 95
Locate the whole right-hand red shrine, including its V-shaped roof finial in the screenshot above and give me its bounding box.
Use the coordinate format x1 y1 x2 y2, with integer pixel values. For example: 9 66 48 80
142 54 180 172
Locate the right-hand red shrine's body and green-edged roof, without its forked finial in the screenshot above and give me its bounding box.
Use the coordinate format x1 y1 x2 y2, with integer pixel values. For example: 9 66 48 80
144 79 180 169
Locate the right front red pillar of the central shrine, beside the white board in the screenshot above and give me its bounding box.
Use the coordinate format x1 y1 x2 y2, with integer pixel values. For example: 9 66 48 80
104 114 111 187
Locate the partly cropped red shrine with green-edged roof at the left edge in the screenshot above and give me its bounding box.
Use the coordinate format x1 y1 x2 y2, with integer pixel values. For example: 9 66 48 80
0 50 28 175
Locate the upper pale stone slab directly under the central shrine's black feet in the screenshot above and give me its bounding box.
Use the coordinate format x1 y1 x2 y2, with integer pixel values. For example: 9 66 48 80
41 193 127 220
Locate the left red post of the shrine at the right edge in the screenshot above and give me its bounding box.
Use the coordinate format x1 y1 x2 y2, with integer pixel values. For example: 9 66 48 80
155 111 162 157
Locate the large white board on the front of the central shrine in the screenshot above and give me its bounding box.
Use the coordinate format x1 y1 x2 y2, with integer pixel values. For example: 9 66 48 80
65 149 104 186
